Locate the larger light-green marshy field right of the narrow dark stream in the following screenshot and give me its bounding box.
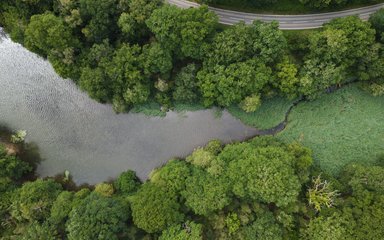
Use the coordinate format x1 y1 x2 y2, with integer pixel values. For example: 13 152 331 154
277 84 384 174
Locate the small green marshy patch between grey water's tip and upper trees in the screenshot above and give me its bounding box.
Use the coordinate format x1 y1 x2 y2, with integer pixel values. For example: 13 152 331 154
228 97 294 130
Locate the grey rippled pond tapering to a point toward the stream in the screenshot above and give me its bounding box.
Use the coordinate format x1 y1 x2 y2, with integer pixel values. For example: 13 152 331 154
0 33 258 184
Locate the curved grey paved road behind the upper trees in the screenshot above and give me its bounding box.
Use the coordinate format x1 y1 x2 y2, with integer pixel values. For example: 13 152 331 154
166 0 384 30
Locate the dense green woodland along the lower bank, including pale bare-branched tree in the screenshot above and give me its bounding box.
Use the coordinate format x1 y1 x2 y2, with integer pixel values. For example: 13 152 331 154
0 137 384 240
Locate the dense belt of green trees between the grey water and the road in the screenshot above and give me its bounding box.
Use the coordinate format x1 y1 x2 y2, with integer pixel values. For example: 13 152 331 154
0 0 384 112
